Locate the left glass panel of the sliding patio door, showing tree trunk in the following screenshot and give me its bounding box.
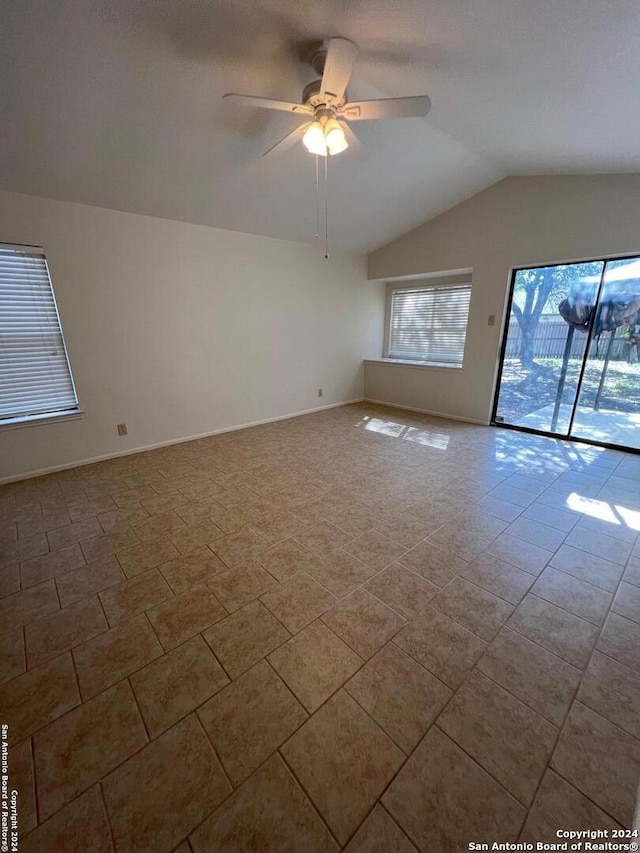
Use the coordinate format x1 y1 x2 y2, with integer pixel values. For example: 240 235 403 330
493 261 604 436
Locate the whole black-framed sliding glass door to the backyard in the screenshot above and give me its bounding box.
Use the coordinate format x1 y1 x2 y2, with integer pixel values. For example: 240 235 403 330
493 258 640 449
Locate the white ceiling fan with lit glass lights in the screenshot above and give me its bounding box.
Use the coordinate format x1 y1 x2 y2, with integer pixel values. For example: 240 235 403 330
224 38 431 157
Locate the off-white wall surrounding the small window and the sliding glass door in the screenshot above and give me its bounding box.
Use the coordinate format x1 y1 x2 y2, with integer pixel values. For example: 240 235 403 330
364 174 640 423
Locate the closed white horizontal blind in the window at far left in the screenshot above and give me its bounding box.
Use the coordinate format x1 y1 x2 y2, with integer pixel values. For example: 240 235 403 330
0 246 78 424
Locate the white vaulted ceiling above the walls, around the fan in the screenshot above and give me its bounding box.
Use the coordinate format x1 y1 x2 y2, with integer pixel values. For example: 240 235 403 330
0 0 640 250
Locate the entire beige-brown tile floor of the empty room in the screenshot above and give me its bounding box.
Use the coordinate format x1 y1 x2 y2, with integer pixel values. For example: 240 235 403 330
0 404 640 853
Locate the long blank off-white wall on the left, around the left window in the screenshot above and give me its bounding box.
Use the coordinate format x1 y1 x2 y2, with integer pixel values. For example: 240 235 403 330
0 193 384 480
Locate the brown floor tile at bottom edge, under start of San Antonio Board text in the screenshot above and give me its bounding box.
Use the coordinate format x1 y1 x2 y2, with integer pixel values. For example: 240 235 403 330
382 727 526 853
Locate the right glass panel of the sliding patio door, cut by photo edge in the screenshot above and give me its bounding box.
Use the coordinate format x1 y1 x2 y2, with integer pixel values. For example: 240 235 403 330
570 258 640 449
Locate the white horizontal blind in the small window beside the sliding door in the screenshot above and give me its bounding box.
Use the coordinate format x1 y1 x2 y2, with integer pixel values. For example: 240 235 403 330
389 284 471 367
